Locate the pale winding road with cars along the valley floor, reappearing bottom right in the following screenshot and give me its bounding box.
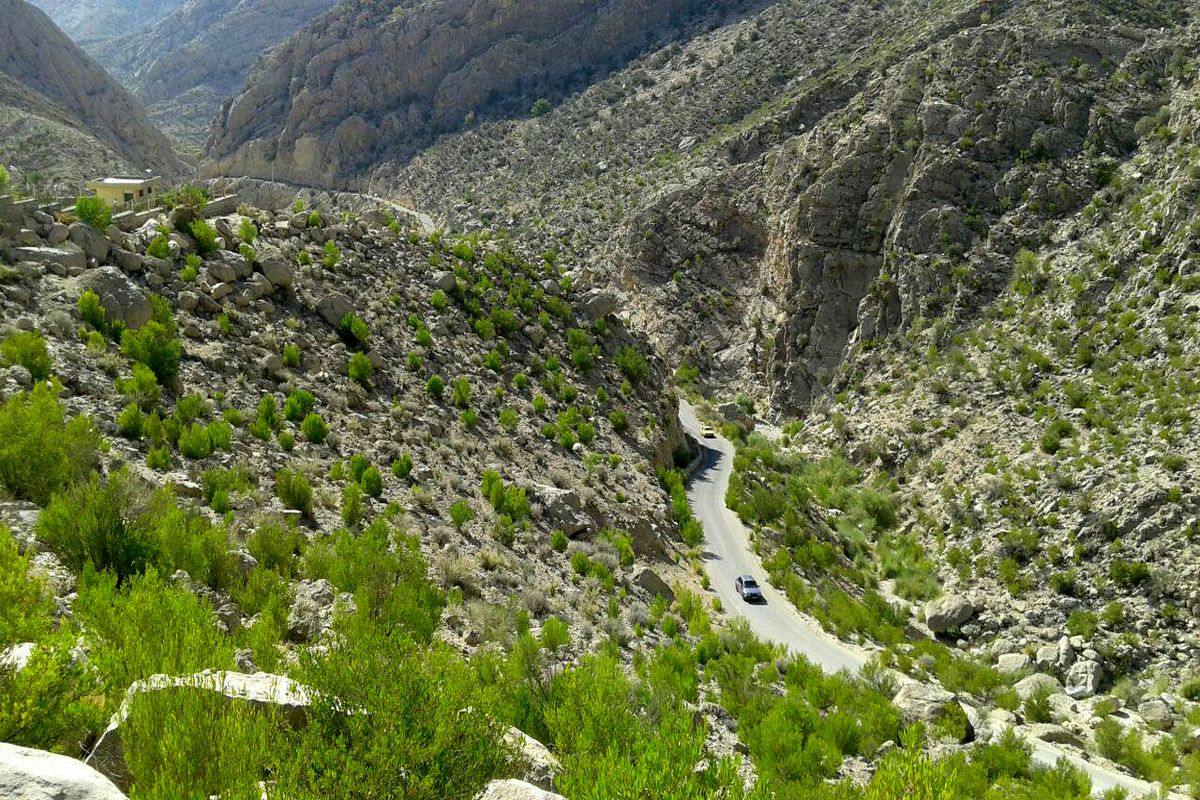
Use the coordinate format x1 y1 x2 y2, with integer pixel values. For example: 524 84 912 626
679 401 1156 798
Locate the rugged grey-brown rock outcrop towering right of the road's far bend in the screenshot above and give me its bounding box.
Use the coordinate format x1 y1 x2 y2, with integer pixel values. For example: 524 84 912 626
614 2 1180 413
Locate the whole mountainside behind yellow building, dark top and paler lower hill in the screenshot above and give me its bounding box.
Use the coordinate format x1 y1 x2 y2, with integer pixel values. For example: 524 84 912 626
0 0 181 185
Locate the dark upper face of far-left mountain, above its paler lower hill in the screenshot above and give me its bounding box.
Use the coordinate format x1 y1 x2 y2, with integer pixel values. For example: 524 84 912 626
0 0 182 178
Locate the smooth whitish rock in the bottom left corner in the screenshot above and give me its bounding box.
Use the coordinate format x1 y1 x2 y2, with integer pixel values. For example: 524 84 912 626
0 744 125 800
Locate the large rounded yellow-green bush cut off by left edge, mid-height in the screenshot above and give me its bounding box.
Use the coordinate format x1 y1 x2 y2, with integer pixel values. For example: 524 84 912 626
0 383 101 505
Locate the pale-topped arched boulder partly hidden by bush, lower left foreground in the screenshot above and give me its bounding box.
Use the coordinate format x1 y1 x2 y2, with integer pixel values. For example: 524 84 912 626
88 672 312 800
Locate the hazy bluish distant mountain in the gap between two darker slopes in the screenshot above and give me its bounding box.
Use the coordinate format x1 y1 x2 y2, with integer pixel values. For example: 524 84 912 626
92 0 335 150
